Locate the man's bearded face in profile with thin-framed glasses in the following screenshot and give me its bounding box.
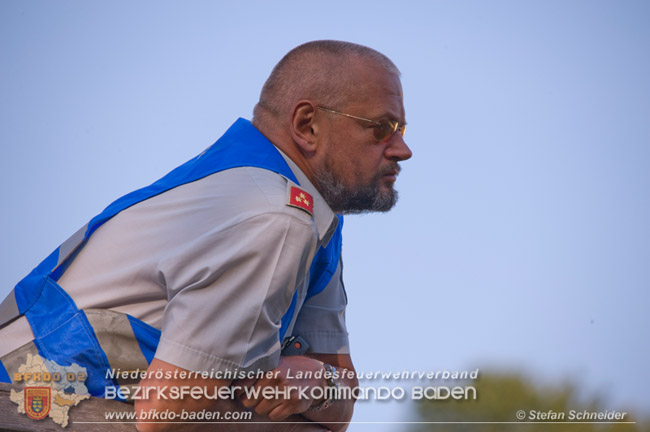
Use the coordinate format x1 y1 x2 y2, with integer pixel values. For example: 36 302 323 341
315 69 412 214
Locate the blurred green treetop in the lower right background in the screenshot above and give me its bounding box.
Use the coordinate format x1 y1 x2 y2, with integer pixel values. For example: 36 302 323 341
411 372 650 432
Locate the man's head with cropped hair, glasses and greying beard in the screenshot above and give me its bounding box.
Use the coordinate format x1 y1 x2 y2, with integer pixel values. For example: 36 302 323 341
253 41 411 213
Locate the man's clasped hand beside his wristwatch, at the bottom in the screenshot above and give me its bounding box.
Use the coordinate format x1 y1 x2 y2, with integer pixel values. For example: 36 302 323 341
238 356 327 421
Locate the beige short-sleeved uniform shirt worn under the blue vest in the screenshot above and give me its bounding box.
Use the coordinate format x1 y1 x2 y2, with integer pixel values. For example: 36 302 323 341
0 149 349 371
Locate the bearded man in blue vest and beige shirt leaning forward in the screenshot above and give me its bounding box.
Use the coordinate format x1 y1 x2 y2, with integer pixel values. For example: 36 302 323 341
0 41 412 430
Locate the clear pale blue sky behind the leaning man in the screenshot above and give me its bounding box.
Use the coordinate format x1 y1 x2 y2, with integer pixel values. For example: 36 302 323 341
0 0 650 431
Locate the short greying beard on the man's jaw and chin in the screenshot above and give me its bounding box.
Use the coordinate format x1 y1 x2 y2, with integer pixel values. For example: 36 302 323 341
314 170 398 214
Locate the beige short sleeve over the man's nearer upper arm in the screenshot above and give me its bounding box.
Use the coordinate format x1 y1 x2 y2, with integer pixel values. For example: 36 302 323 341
156 208 313 370
